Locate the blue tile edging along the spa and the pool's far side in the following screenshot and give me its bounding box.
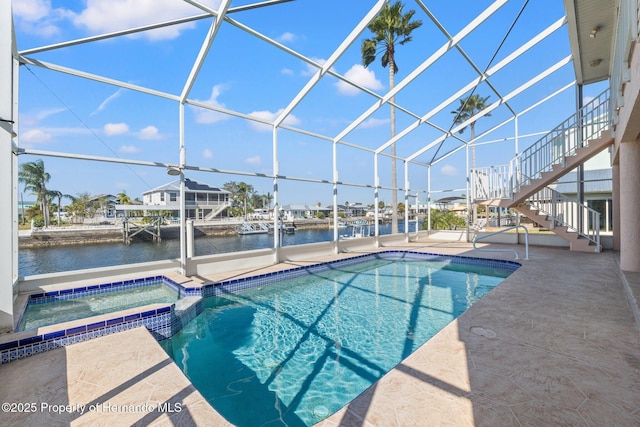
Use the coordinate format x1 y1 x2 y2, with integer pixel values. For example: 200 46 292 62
0 249 522 365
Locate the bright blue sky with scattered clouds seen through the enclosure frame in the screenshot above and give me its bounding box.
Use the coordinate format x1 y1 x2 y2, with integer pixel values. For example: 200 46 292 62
12 0 604 205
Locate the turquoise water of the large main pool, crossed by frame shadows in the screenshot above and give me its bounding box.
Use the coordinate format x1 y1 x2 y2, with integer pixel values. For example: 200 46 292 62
162 259 511 426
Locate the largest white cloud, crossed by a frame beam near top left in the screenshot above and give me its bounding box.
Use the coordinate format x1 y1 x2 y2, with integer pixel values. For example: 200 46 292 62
72 0 220 40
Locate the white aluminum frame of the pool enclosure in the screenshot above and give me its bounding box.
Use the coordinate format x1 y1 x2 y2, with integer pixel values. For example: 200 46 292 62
0 0 584 327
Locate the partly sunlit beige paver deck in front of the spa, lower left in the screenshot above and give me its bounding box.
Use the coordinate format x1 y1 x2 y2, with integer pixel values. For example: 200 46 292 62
0 328 230 427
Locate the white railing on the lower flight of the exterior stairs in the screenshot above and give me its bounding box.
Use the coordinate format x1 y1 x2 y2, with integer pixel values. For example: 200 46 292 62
526 187 601 252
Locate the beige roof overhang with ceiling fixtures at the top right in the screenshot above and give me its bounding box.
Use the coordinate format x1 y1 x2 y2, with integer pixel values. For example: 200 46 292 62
564 0 619 84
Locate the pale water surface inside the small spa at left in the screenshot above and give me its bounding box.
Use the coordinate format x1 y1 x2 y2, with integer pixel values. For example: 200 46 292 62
20 283 178 330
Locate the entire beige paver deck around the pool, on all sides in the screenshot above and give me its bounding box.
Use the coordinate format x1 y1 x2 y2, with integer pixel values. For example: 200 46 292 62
0 242 640 427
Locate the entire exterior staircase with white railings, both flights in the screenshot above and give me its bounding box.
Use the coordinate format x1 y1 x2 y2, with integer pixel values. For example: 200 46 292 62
471 90 613 252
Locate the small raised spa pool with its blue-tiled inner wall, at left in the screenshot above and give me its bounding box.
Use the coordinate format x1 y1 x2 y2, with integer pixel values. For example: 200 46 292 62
18 276 180 331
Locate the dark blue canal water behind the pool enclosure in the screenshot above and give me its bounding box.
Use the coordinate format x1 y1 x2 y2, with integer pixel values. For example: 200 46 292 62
18 222 415 276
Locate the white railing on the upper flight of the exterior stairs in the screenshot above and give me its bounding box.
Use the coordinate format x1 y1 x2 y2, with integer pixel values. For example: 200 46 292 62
514 89 610 192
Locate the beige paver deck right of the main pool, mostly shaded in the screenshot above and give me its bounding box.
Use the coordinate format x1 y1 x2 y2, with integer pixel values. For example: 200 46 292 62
320 244 640 427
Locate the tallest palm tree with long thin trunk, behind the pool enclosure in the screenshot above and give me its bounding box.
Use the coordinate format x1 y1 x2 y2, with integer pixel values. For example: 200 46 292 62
361 1 422 233
